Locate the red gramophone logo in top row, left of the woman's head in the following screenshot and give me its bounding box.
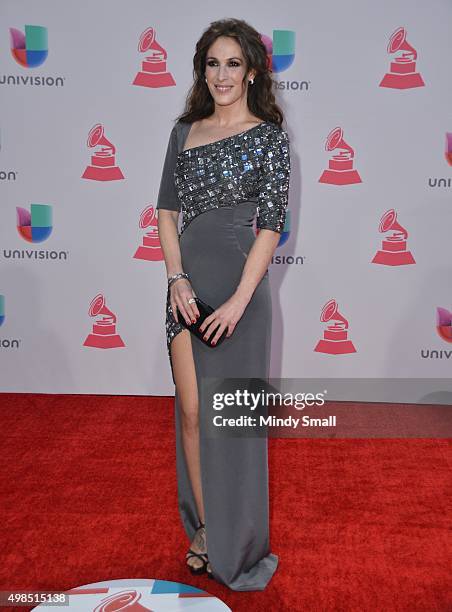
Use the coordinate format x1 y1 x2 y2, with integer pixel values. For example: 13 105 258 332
133 28 176 88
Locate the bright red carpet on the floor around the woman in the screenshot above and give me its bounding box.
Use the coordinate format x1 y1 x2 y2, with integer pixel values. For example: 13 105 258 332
0 394 452 612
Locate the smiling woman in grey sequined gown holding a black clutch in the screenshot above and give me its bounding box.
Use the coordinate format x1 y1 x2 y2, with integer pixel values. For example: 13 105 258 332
157 19 290 591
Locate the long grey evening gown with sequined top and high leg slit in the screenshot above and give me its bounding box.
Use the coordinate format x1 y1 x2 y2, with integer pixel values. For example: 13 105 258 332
157 121 290 591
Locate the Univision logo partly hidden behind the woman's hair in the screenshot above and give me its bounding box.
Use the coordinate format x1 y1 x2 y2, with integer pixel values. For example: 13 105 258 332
261 30 310 91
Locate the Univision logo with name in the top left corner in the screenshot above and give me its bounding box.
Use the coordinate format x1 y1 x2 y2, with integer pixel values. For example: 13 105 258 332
0 25 64 87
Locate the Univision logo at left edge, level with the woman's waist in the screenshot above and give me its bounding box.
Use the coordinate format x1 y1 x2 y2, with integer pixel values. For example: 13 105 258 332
3 204 68 260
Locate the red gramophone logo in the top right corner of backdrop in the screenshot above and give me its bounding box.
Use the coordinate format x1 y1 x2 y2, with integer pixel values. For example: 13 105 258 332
380 28 425 89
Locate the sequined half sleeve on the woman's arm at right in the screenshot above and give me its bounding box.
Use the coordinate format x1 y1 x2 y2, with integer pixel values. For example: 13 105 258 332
256 128 290 234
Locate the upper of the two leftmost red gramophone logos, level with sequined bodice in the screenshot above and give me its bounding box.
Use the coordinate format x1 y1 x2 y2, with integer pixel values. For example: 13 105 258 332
82 123 124 181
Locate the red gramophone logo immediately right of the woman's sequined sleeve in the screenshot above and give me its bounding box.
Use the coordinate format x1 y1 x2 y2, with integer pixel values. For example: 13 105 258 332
319 127 362 185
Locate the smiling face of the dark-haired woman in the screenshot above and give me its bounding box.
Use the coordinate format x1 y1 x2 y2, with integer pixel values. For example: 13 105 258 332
206 36 254 106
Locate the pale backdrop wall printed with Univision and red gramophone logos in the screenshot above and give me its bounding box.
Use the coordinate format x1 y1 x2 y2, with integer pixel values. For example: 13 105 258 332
0 0 452 401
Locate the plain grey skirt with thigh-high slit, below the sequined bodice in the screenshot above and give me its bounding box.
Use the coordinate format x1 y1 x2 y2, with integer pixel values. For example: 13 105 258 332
168 201 278 591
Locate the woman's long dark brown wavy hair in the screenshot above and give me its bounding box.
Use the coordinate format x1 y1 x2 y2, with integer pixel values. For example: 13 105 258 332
177 19 284 127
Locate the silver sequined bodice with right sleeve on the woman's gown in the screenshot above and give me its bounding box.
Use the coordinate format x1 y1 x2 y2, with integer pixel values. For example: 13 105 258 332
174 122 289 234
